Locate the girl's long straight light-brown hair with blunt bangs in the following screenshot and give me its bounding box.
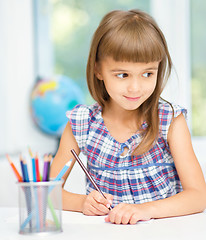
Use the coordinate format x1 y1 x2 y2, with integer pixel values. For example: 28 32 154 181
87 9 172 154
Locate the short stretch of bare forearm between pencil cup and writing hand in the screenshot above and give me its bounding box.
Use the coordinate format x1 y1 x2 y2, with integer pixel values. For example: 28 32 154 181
62 189 86 212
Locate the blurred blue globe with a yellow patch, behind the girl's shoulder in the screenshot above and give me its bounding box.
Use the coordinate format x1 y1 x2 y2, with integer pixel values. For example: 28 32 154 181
31 76 84 137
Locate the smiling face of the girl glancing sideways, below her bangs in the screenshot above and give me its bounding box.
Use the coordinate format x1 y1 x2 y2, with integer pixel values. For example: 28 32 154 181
95 57 159 110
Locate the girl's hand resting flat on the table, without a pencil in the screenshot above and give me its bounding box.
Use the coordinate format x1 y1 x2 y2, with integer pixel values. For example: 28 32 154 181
105 203 152 224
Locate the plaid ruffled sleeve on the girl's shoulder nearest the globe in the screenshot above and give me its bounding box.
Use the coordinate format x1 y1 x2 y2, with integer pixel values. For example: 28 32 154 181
66 105 91 151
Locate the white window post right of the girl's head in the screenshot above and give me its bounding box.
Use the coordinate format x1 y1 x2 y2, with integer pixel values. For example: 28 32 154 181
151 0 191 117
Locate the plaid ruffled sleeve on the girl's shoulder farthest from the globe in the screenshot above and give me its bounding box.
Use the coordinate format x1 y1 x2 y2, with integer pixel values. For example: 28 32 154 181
159 102 187 142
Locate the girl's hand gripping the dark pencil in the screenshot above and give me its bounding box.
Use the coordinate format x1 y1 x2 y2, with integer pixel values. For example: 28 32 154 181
82 190 113 216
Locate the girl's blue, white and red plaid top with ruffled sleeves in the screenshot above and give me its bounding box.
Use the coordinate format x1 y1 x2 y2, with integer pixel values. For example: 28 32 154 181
66 101 186 205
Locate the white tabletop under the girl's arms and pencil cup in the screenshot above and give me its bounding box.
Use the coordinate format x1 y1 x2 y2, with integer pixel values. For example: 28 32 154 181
0 208 206 240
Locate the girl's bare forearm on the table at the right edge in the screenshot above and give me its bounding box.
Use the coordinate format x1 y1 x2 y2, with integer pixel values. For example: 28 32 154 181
149 189 206 218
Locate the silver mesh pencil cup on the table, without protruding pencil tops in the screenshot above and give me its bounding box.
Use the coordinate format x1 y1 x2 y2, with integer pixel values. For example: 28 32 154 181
17 181 63 234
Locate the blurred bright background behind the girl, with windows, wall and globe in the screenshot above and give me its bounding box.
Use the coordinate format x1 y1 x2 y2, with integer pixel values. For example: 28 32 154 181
0 0 206 204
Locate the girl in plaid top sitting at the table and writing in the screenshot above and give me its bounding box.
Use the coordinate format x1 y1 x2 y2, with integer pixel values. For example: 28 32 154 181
51 10 206 224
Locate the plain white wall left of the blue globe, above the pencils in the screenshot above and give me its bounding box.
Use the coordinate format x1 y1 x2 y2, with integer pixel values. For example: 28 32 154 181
0 0 56 154
